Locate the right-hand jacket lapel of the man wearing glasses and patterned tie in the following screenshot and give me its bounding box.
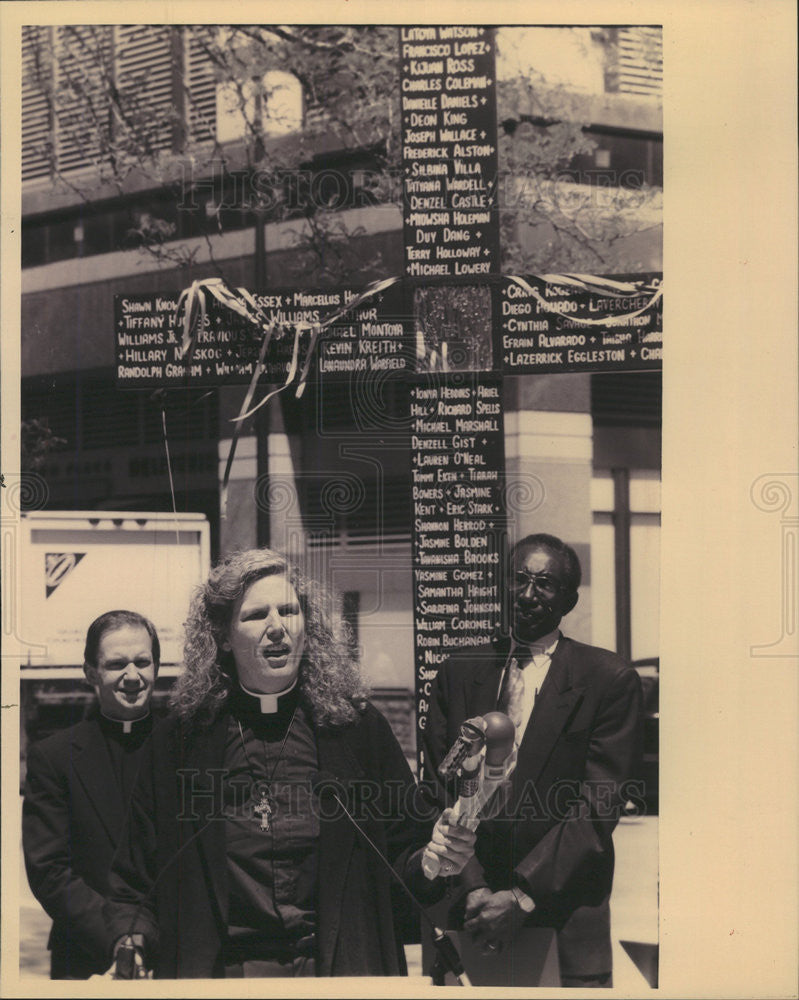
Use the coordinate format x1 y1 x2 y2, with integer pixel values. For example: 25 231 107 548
512 638 584 794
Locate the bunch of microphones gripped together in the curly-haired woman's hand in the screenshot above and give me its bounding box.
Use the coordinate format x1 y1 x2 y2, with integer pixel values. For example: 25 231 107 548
422 712 516 881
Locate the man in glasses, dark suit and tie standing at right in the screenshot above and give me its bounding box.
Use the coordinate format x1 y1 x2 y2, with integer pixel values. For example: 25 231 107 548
424 534 642 987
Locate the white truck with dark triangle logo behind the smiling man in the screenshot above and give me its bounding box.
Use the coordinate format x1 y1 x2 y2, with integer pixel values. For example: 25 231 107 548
14 511 210 745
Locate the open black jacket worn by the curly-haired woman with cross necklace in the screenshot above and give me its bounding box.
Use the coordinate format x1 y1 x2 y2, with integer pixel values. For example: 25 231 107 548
106 702 443 978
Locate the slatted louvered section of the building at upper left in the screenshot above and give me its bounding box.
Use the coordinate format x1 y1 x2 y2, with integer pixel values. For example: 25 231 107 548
22 24 215 181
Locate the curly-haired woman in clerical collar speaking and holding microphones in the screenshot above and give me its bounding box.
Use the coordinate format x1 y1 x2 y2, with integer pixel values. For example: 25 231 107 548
108 549 474 978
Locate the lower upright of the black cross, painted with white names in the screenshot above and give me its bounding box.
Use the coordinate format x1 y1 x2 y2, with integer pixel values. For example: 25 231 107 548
410 373 507 752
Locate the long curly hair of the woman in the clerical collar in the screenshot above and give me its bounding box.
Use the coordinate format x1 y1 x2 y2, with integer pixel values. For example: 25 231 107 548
170 549 366 725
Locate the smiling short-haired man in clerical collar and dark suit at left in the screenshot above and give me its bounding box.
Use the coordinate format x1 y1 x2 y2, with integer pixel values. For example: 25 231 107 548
22 611 160 979
